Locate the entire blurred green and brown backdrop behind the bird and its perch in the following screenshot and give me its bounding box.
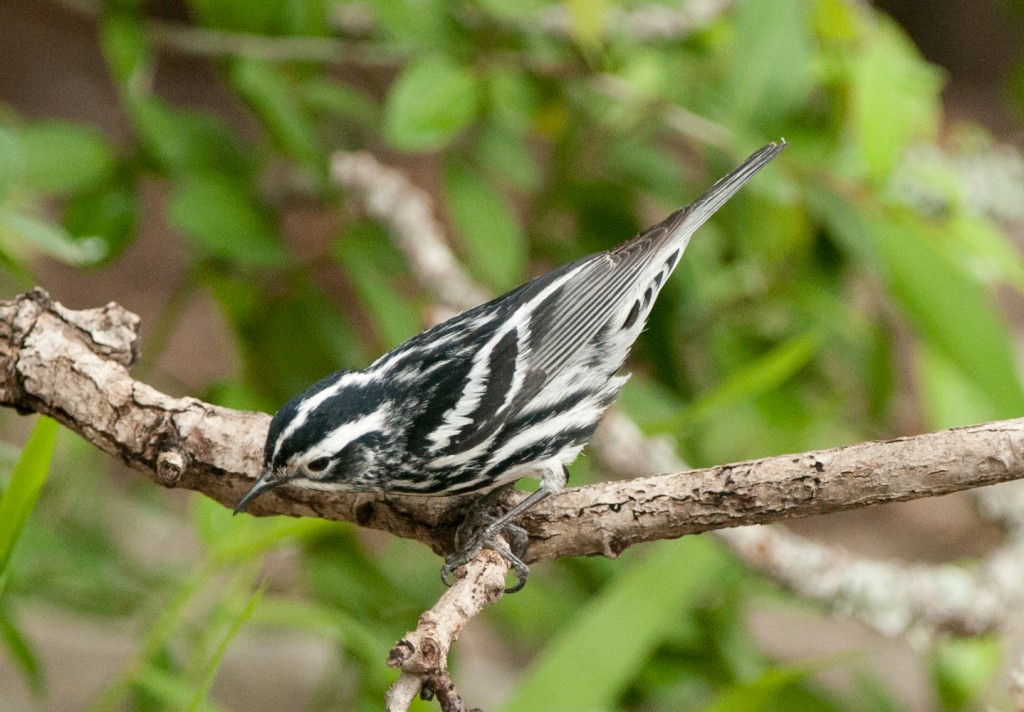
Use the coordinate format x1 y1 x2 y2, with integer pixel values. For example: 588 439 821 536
0 0 1024 712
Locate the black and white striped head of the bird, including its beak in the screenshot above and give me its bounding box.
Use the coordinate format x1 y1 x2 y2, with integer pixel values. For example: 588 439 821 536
234 371 389 512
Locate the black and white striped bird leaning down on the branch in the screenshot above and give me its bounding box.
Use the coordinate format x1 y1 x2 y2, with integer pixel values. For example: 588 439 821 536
234 139 786 592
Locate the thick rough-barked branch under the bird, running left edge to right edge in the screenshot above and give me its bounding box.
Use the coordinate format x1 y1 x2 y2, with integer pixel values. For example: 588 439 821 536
0 289 1024 561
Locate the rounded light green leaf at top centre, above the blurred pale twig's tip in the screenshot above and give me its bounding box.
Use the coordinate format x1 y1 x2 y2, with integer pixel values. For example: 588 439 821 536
384 56 477 151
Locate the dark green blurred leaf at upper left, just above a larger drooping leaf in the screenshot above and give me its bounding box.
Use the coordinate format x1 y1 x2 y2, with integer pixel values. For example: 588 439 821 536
132 98 250 175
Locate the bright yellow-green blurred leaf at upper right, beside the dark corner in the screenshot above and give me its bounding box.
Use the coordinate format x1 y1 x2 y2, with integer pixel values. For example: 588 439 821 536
850 17 942 179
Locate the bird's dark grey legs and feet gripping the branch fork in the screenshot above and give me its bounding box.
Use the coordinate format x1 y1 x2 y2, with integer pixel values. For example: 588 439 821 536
441 466 568 593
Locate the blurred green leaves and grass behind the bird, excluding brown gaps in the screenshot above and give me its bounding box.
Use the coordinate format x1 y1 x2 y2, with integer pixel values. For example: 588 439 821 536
0 0 1024 712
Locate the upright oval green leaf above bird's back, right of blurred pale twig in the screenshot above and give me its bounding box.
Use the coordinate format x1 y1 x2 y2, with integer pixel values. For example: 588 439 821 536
444 160 528 291
